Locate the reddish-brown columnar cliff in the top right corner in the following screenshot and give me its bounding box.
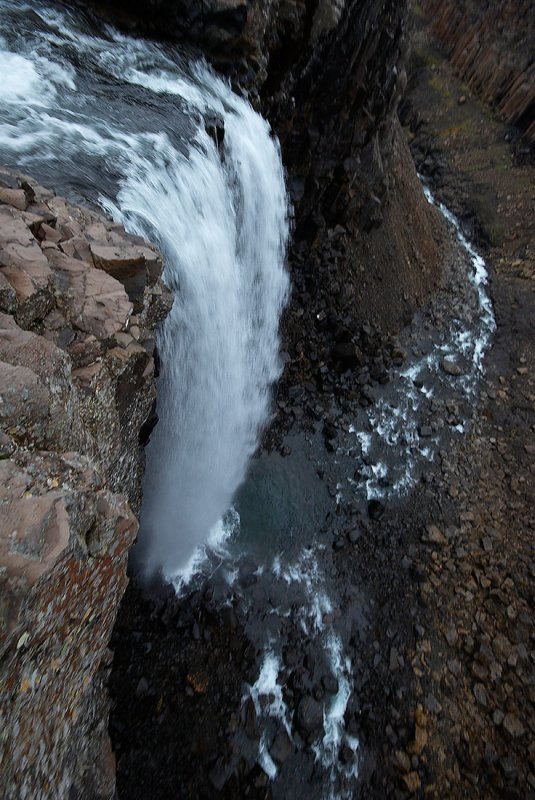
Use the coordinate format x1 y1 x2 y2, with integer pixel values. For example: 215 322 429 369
421 0 535 142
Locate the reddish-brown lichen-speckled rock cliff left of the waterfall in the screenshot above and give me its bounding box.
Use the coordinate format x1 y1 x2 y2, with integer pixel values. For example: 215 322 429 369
0 166 170 799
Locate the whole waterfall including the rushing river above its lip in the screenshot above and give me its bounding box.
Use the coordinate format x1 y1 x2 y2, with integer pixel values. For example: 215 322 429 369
0 0 288 578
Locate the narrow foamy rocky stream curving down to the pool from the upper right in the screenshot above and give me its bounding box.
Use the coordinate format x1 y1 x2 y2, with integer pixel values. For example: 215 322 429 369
344 184 496 501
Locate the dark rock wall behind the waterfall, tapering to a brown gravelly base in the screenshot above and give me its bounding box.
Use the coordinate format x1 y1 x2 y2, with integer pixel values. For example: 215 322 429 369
97 0 441 332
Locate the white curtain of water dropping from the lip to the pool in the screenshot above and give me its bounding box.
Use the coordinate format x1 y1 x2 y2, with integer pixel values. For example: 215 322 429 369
118 69 287 577
